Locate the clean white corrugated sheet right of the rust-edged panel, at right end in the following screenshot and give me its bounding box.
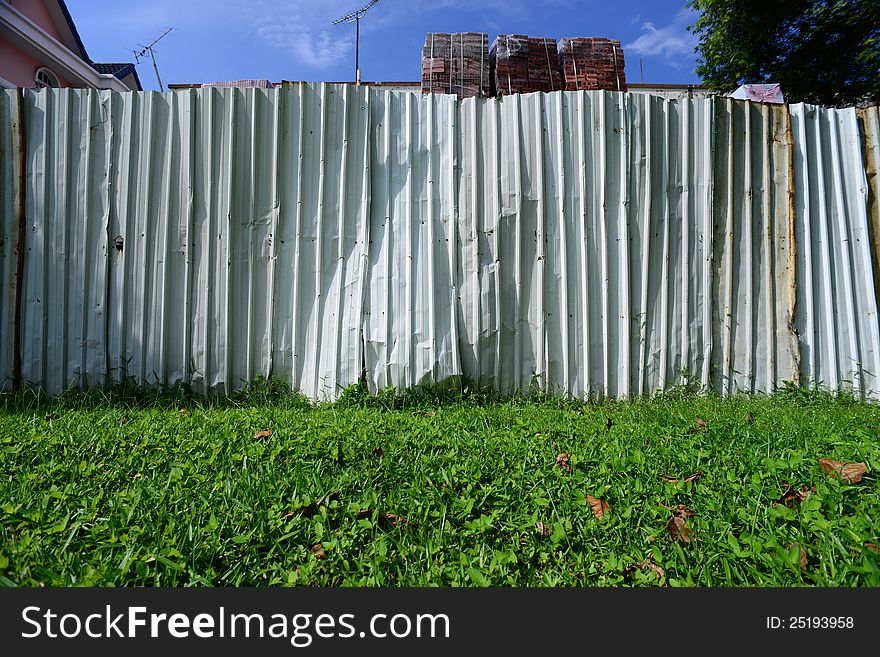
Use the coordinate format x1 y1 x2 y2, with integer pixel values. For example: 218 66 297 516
791 105 880 396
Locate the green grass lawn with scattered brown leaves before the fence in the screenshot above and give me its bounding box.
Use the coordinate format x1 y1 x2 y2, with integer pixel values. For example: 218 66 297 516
0 387 880 586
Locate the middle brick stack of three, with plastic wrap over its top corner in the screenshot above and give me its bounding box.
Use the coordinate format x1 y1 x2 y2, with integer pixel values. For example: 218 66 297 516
489 34 565 96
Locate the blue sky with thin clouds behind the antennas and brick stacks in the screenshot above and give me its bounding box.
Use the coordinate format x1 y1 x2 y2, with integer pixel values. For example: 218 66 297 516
67 0 699 89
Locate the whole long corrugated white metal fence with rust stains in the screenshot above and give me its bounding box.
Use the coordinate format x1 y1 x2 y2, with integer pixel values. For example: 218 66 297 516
0 84 880 399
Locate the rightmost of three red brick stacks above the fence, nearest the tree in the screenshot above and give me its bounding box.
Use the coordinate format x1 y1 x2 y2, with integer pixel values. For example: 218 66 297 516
559 37 626 91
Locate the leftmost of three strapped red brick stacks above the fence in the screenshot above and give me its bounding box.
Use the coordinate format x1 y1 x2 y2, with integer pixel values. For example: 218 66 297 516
422 32 489 98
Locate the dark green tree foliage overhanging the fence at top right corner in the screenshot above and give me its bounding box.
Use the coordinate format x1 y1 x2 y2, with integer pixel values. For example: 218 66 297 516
688 0 880 105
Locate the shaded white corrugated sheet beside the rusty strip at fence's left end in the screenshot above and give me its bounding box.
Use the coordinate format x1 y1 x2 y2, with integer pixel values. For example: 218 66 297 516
21 91 113 391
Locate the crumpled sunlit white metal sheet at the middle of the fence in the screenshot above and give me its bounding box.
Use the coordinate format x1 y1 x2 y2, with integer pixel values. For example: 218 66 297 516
364 91 461 390
